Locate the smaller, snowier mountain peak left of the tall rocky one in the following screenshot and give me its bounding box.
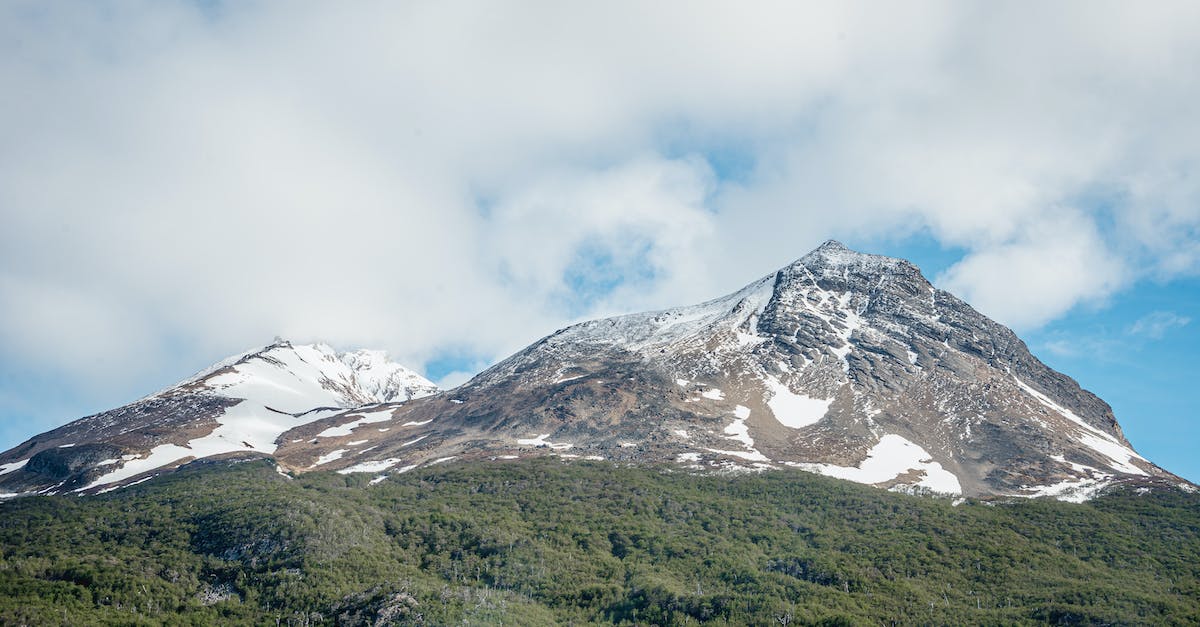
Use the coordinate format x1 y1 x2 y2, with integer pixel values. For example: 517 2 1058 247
0 340 438 494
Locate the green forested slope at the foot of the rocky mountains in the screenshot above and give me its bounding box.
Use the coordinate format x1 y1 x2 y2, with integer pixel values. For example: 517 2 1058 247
0 458 1200 625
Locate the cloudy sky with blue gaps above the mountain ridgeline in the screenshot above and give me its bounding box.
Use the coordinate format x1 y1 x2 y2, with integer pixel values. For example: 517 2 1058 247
0 0 1200 480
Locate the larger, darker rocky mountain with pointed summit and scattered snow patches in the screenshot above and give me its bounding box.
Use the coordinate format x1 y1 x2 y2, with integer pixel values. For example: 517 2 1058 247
278 241 1177 498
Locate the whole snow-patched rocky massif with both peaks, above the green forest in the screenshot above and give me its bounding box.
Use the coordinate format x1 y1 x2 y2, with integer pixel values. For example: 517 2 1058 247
0 241 1192 500
